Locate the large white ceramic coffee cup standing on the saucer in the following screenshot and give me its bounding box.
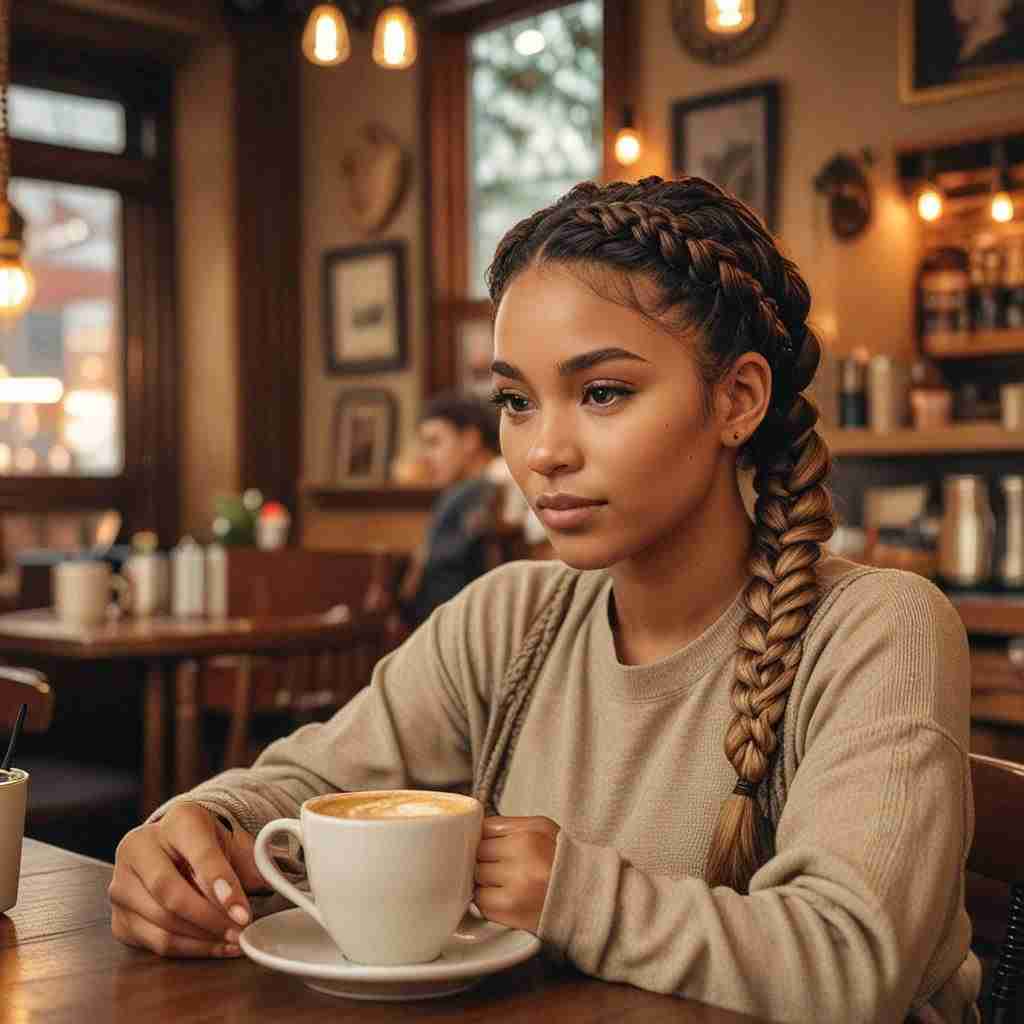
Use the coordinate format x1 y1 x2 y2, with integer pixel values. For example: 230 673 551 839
255 790 483 965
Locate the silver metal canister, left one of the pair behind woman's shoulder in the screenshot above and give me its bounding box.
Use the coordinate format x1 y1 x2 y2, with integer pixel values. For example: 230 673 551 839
939 473 995 587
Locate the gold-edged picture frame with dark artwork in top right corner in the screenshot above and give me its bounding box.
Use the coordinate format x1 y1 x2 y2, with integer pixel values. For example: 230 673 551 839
899 0 1024 103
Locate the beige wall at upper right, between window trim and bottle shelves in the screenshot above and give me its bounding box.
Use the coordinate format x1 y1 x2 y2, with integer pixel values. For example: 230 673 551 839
633 0 1024 380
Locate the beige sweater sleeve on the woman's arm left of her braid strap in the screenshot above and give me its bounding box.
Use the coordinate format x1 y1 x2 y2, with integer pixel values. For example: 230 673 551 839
148 563 573 834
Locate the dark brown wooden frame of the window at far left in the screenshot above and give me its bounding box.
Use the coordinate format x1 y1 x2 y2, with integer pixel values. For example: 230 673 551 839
0 19 179 543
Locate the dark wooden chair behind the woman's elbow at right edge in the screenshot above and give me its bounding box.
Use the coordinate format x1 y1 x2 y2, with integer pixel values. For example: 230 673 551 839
967 754 1024 1024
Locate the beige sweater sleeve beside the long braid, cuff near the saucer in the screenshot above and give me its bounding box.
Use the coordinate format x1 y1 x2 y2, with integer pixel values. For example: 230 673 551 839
539 572 973 1024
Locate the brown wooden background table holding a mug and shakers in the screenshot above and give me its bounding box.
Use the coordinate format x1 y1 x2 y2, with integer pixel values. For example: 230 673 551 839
0 605 385 814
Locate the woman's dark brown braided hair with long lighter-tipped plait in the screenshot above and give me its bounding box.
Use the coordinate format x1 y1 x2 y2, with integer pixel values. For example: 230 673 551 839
487 176 835 892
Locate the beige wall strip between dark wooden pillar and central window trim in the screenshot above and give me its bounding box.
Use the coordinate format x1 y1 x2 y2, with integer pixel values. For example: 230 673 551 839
302 46 426 480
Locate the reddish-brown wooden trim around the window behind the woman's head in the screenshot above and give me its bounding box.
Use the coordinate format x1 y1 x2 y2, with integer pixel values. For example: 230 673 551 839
421 0 633 397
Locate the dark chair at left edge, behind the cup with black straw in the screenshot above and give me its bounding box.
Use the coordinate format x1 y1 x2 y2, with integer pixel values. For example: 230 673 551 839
0 666 140 857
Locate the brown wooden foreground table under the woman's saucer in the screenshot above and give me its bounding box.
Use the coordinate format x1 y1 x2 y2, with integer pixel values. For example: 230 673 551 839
0 840 770 1024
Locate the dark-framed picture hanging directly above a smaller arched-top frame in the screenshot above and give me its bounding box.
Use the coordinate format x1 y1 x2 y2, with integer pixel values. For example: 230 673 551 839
322 241 409 375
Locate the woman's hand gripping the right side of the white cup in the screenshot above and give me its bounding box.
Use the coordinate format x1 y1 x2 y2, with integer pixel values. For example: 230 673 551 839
473 817 560 935
